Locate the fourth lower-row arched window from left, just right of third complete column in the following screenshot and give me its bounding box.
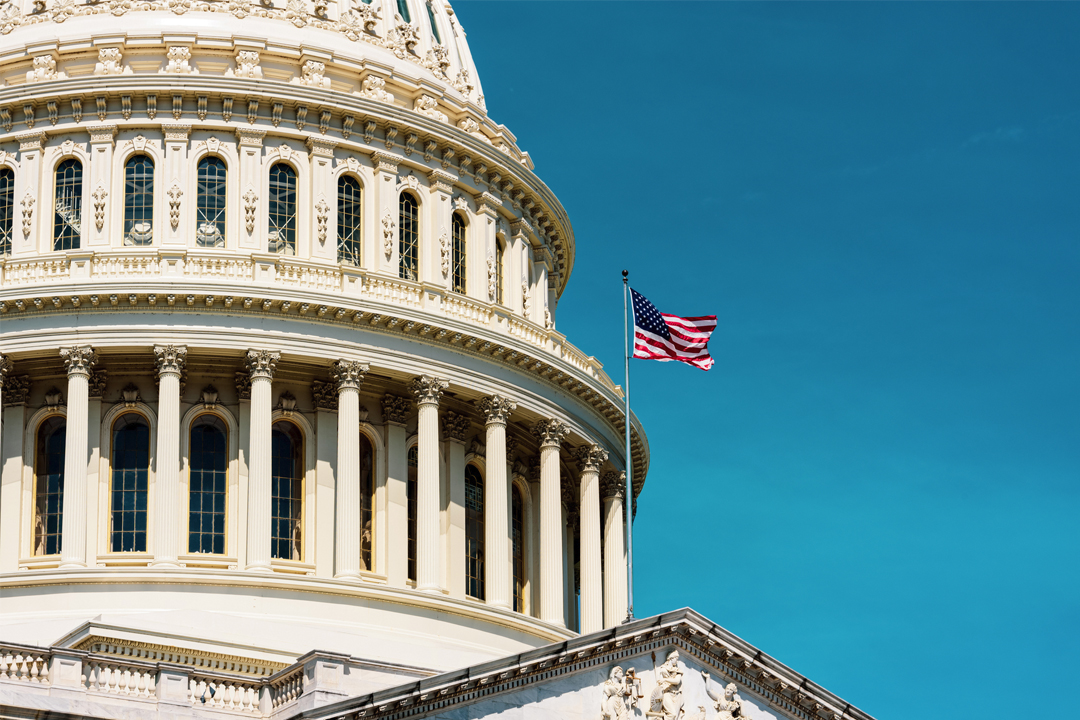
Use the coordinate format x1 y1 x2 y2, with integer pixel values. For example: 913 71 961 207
270 420 303 561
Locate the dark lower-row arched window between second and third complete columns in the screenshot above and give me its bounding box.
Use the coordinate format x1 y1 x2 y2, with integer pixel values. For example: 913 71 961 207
188 415 229 555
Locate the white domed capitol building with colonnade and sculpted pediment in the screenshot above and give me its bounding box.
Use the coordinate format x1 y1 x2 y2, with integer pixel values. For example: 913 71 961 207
0 0 868 720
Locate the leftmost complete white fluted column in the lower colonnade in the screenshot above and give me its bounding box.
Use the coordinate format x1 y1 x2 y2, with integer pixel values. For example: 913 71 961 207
60 345 97 568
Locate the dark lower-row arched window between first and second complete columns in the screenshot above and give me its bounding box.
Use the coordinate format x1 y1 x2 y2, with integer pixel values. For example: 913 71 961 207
109 412 150 553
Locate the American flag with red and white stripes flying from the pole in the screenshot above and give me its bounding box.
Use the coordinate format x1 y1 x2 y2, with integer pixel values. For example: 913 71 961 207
630 288 716 370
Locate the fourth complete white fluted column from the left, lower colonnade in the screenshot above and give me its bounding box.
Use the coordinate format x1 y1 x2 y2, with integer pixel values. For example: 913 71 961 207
330 359 368 580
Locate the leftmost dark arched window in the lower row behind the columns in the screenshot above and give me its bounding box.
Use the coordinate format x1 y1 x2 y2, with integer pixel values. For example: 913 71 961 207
33 415 67 555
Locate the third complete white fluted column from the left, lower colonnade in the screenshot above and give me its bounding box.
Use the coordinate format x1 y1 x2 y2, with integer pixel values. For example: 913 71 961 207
245 350 281 572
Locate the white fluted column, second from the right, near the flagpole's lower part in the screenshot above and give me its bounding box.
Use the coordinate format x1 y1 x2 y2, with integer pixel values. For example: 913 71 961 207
576 445 607 634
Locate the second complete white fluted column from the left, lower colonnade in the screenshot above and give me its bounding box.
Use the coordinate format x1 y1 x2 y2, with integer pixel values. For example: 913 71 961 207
151 345 188 568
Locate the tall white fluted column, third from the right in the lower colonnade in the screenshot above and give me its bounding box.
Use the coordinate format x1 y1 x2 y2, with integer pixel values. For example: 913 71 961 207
532 419 569 626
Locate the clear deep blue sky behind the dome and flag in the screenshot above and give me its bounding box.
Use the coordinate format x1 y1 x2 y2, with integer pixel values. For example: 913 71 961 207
454 0 1080 720
